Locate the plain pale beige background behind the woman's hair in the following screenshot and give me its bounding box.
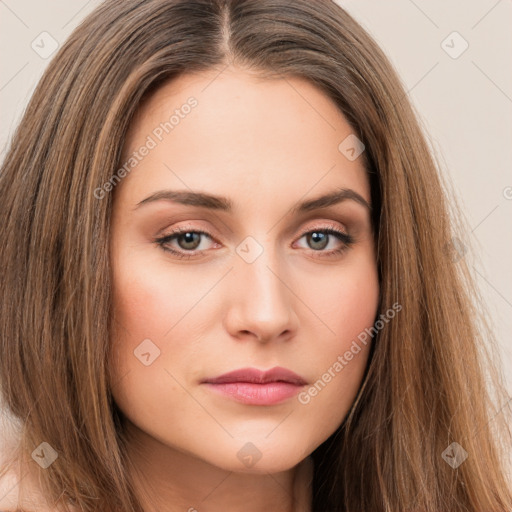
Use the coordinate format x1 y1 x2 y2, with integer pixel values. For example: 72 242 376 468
0 0 512 403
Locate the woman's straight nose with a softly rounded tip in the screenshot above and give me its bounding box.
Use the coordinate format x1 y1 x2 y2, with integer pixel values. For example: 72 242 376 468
225 246 298 343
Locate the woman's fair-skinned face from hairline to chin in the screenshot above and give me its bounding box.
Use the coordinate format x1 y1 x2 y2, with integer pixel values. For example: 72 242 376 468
111 68 379 472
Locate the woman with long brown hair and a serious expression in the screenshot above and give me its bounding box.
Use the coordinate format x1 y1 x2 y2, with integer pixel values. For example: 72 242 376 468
0 0 512 512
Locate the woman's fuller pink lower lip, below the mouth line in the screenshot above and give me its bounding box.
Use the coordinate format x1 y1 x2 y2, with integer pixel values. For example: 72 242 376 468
201 382 302 405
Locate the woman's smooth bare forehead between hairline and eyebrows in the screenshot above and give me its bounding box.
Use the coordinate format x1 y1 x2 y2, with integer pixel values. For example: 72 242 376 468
116 68 370 212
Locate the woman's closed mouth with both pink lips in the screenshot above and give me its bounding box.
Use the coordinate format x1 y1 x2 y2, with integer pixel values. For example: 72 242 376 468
202 366 307 405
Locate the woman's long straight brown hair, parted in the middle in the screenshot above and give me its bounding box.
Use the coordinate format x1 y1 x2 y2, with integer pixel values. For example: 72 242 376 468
0 0 512 512
